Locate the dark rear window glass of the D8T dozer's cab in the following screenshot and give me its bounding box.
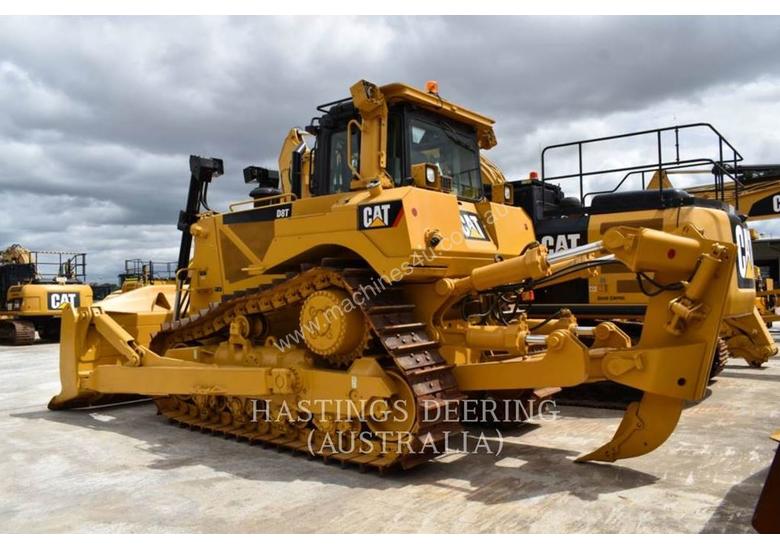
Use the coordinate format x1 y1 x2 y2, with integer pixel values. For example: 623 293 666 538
409 118 482 200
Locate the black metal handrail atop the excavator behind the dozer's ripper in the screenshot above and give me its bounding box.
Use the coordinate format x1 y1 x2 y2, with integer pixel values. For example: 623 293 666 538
540 122 743 208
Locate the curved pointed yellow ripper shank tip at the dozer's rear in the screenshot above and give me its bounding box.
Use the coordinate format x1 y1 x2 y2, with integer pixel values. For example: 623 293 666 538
575 393 684 462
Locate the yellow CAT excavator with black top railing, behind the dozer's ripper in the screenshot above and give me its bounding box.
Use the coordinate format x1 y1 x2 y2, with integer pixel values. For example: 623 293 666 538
506 123 777 371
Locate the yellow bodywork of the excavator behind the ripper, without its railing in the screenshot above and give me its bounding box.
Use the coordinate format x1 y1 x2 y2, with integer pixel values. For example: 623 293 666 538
537 166 777 366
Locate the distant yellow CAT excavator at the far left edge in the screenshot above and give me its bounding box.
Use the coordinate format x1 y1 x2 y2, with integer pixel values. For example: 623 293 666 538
0 244 92 345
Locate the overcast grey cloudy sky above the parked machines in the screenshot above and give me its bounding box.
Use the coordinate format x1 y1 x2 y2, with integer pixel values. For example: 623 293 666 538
0 16 780 281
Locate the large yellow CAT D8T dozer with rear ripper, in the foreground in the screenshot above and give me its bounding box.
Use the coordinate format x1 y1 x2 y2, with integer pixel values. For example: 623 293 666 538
49 81 755 470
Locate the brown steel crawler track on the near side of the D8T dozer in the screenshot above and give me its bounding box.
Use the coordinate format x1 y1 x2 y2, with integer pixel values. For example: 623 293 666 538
151 258 463 472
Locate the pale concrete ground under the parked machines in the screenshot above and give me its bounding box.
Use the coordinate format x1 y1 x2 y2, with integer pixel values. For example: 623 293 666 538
0 334 780 533
